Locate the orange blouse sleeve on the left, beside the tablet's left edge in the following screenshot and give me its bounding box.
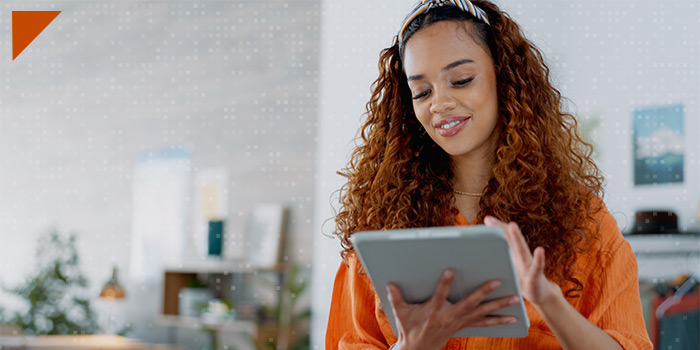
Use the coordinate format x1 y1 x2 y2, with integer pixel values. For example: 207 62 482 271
326 256 389 350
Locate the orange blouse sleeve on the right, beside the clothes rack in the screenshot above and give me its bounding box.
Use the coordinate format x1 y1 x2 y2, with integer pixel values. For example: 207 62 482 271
589 208 653 350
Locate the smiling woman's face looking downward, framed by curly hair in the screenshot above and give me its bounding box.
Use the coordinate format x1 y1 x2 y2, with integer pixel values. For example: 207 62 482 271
403 21 498 157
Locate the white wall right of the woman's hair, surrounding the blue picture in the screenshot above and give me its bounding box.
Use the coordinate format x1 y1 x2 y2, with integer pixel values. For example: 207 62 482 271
504 0 700 231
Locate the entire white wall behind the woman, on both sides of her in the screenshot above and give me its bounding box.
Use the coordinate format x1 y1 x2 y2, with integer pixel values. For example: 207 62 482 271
312 0 700 349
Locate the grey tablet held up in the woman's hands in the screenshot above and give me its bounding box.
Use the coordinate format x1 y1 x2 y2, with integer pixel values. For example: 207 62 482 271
350 225 530 337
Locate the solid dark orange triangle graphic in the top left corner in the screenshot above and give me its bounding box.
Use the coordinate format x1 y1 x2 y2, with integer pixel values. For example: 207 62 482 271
12 11 61 61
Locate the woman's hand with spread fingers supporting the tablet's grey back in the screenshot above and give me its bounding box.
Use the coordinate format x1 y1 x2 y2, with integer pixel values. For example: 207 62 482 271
386 269 519 350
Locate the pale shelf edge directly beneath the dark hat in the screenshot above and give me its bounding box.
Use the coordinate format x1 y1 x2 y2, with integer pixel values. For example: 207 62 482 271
624 234 700 255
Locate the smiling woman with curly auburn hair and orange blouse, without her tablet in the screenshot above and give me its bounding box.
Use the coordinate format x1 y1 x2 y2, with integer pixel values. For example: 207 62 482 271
326 0 651 350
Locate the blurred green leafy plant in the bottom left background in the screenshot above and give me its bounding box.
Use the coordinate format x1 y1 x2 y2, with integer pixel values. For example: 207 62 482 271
0 231 99 335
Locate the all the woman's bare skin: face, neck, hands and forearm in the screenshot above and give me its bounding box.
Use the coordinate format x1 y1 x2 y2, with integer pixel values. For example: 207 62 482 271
387 21 621 350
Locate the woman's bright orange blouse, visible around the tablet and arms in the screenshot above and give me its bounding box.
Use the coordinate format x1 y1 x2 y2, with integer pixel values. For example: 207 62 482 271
326 202 652 350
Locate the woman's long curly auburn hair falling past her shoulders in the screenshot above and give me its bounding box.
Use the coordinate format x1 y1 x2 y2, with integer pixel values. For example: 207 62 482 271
333 0 604 297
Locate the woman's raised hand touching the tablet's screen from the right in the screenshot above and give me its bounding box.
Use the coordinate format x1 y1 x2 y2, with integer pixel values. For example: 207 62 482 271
484 216 561 307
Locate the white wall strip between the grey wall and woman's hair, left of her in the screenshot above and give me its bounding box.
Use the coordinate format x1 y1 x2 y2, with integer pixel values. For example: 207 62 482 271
311 0 411 349
